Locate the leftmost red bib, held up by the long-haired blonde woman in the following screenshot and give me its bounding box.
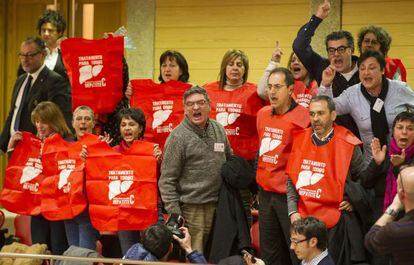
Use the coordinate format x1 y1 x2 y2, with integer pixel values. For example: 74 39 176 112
0 132 43 215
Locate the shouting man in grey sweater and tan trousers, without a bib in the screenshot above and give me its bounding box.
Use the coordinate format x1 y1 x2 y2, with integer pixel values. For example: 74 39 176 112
159 86 231 252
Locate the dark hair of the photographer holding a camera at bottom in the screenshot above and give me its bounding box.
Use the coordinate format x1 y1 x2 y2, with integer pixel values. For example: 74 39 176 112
142 224 173 259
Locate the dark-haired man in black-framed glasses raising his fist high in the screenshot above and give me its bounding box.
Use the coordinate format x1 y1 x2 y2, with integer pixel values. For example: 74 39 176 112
293 0 359 137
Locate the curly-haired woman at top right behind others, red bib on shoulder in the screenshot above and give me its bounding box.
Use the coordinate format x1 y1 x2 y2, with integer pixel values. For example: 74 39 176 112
358 25 407 82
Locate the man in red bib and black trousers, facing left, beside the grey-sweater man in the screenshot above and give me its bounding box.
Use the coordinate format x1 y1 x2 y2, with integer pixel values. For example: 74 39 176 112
256 67 309 265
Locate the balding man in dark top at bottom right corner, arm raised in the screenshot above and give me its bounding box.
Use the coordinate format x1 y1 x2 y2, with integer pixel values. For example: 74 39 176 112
365 164 414 265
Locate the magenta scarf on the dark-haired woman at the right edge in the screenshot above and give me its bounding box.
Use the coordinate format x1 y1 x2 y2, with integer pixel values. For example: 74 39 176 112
384 138 414 211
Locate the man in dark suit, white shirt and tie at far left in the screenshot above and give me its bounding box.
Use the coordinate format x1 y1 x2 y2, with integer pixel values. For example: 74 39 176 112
0 37 72 152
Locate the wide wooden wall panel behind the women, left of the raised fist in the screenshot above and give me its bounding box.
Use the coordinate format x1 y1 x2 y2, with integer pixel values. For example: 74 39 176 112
154 0 309 84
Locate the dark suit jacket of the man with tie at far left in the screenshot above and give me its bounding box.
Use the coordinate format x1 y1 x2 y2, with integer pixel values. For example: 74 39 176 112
0 66 72 152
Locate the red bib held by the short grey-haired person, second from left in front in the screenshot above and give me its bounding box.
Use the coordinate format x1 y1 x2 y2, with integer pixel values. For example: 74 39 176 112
41 134 99 221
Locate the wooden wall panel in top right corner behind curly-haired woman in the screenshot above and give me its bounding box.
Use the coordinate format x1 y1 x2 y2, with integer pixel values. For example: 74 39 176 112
342 0 414 88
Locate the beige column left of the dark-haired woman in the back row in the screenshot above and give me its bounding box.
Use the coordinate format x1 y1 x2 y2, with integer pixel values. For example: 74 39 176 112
125 0 155 79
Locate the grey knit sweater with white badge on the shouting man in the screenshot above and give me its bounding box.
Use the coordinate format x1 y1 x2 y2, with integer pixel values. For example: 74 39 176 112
159 117 231 214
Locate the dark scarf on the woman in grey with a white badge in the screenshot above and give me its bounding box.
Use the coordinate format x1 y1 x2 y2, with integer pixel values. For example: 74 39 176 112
361 76 389 146
